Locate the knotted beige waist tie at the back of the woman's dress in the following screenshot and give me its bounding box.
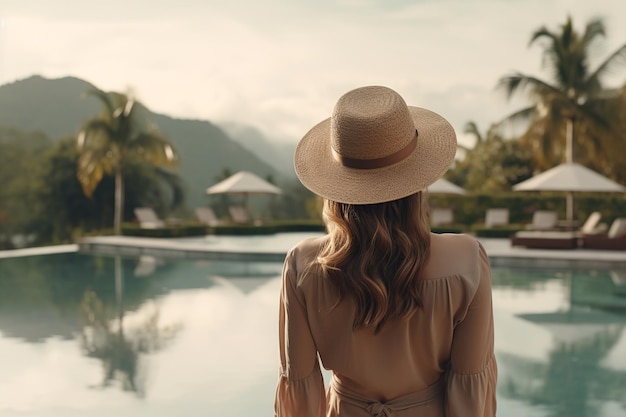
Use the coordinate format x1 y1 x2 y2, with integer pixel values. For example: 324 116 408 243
329 376 444 417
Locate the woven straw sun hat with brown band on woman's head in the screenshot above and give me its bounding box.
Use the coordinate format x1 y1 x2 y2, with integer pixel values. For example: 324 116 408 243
294 86 456 204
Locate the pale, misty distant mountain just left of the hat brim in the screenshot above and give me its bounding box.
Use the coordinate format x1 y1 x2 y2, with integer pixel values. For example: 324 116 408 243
218 122 296 176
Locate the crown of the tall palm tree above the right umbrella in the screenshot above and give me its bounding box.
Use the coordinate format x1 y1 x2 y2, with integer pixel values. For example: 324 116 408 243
498 16 626 168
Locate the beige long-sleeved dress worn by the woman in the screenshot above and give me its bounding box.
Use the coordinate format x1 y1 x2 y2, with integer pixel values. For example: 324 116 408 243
275 234 497 417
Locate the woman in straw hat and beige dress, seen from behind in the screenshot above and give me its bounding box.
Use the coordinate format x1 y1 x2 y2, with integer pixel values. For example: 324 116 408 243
275 87 497 417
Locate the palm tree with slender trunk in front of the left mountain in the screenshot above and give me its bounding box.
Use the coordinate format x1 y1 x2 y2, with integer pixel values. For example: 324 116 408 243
77 89 177 234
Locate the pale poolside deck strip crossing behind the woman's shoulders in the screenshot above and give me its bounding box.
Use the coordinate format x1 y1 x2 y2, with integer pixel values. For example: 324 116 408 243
0 233 626 267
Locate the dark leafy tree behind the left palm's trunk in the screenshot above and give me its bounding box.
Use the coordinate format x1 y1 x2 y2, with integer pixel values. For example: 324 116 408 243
32 136 182 244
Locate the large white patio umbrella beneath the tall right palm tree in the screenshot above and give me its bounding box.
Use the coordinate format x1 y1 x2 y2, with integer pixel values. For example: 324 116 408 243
513 162 626 222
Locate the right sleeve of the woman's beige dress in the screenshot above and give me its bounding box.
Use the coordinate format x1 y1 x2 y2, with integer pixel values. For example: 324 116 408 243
446 244 498 417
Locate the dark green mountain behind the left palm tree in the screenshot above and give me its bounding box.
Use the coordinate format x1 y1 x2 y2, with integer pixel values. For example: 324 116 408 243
0 76 291 208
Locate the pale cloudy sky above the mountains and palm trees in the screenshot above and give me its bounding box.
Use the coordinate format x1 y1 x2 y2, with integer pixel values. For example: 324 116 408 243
0 0 626 145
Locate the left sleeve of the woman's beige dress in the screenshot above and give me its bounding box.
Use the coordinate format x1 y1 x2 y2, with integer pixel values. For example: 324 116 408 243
274 249 326 417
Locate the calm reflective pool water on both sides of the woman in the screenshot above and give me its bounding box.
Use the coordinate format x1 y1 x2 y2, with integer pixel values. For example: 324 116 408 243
0 253 626 417
